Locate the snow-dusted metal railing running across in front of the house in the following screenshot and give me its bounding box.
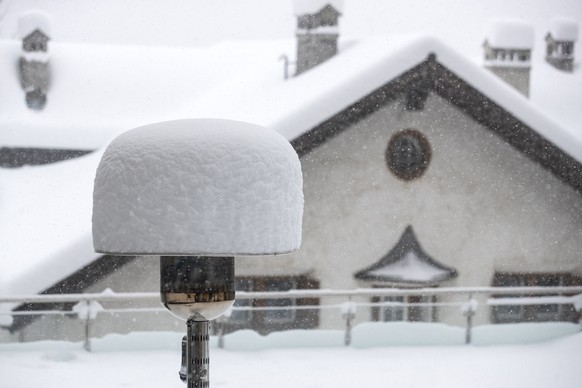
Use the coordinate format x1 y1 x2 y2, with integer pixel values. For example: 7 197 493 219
0 286 582 350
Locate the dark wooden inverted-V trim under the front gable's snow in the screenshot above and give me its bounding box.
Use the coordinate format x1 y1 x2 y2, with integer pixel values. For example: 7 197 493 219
291 54 582 194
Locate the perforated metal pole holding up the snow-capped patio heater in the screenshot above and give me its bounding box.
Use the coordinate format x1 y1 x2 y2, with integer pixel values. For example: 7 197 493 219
186 317 210 388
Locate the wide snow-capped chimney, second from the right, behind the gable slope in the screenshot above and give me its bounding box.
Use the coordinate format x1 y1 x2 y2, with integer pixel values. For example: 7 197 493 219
483 20 534 96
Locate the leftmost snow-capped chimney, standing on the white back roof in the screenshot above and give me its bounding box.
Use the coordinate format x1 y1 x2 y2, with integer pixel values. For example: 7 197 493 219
18 11 51 110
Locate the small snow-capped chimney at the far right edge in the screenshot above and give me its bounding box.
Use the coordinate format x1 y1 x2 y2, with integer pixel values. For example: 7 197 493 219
546 18 578 72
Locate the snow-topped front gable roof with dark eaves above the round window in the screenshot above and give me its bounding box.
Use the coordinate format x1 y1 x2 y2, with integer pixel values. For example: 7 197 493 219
229 37 582 191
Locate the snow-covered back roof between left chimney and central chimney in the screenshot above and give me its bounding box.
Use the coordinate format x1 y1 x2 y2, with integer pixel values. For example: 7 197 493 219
0 41 288 149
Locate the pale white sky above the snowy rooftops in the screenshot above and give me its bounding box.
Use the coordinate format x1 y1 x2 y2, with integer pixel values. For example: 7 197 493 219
0 0 582 56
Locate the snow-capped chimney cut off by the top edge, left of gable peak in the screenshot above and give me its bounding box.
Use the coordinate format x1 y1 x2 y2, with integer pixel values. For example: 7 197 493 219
294 0 343 75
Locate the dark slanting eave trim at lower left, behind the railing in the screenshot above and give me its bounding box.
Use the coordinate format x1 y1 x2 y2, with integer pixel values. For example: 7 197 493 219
8 256 135 333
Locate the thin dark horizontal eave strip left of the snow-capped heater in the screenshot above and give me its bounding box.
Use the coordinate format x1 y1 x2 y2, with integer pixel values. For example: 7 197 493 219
0 147 92 167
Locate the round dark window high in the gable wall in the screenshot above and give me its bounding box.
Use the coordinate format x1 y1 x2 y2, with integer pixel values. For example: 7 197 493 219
386 129 431 181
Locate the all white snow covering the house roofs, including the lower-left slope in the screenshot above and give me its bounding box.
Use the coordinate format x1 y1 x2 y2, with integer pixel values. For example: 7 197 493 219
0 31 582 314
